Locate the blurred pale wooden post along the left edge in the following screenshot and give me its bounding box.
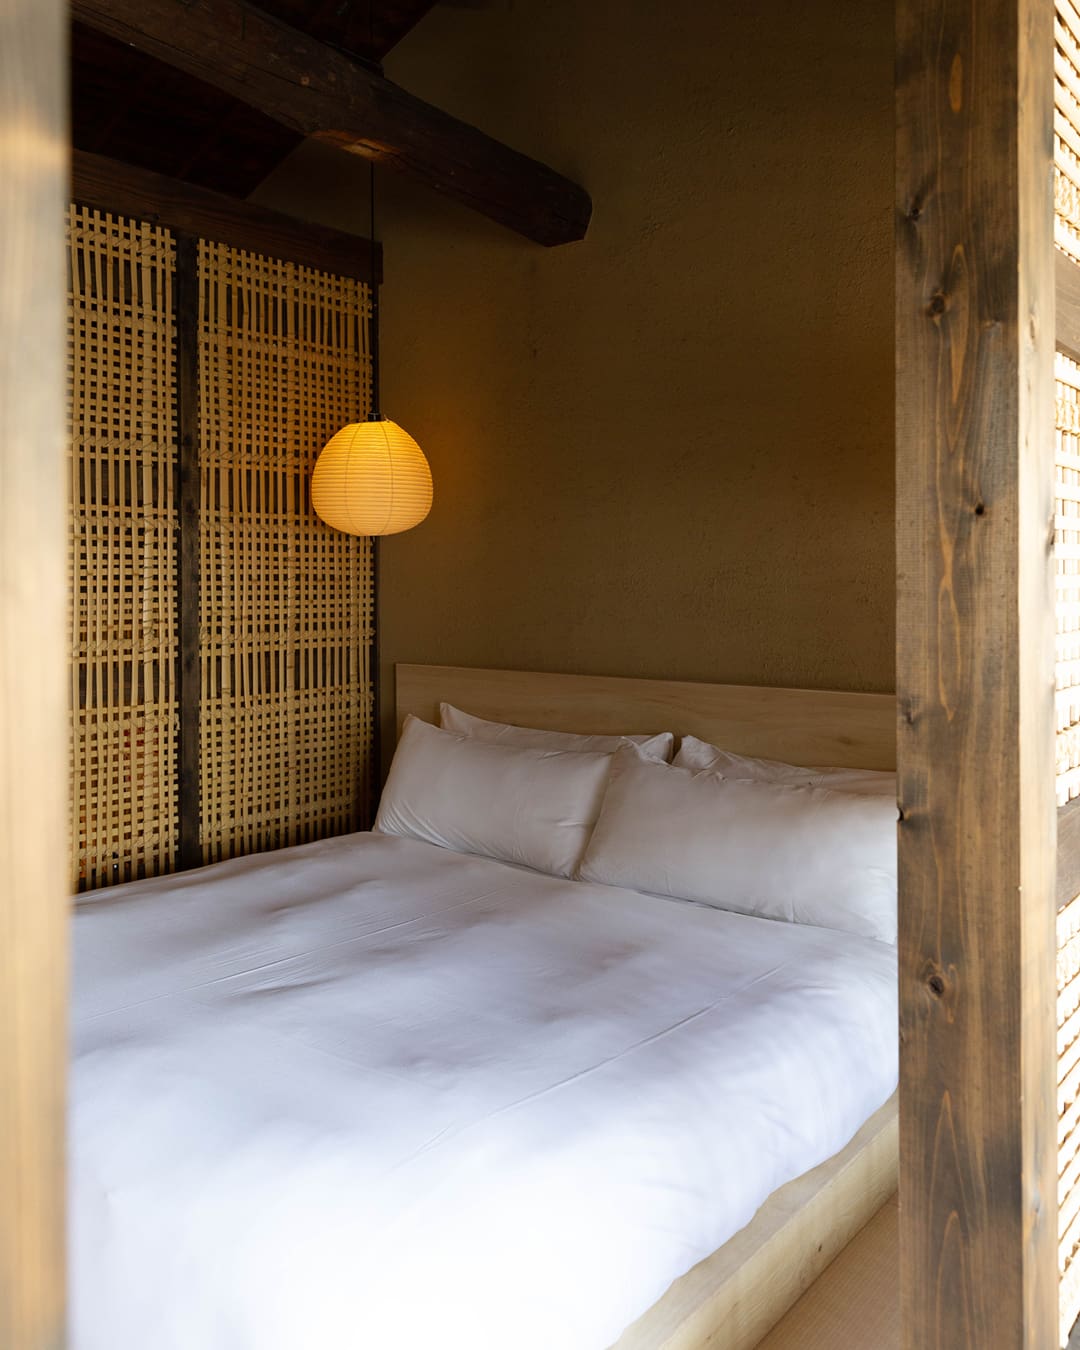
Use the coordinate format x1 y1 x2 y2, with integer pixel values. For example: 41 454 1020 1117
0 0 68 1350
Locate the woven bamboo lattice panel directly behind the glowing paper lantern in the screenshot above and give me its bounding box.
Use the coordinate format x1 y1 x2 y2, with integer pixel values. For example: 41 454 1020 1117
200 242 374 861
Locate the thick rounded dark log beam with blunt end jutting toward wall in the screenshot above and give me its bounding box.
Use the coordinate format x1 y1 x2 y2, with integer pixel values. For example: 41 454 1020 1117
72 0 593 244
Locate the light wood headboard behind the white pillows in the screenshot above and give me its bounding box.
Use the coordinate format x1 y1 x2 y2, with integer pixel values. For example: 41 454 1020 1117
397 666 896 770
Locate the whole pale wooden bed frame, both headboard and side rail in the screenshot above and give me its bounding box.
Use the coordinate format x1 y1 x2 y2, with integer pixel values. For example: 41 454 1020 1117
397 666 898 1350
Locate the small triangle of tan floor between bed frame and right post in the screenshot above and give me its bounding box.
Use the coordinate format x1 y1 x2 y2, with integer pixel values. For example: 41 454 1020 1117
757 1196 900 1350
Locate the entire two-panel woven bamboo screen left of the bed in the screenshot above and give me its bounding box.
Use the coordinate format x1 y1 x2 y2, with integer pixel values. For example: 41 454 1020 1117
70 207 374 888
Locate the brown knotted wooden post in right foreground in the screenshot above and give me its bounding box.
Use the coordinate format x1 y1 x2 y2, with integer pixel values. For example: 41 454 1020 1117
896 0 1058 1350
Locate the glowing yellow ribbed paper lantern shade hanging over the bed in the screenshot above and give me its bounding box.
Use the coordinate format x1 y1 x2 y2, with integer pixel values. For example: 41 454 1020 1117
312 417 432 535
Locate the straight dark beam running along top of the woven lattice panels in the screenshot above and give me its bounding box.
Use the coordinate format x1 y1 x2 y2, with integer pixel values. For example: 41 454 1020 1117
72 150 382 281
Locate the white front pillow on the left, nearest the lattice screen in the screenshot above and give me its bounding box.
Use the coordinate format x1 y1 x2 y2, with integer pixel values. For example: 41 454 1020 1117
375 717 612 876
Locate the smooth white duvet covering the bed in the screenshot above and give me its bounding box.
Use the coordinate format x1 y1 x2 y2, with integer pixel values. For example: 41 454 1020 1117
70 834 896 1350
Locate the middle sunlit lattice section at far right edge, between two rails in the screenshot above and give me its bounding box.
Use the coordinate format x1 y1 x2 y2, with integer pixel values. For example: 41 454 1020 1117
1054 352 1080 805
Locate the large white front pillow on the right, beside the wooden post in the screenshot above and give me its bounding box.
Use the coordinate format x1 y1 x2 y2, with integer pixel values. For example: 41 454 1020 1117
578 745 896 942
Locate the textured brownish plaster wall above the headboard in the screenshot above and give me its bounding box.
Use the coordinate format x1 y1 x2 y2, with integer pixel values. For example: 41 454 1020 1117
261 0 894 761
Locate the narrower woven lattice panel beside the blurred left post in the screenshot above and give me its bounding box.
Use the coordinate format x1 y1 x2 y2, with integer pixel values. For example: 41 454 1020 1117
69 207 178 888
